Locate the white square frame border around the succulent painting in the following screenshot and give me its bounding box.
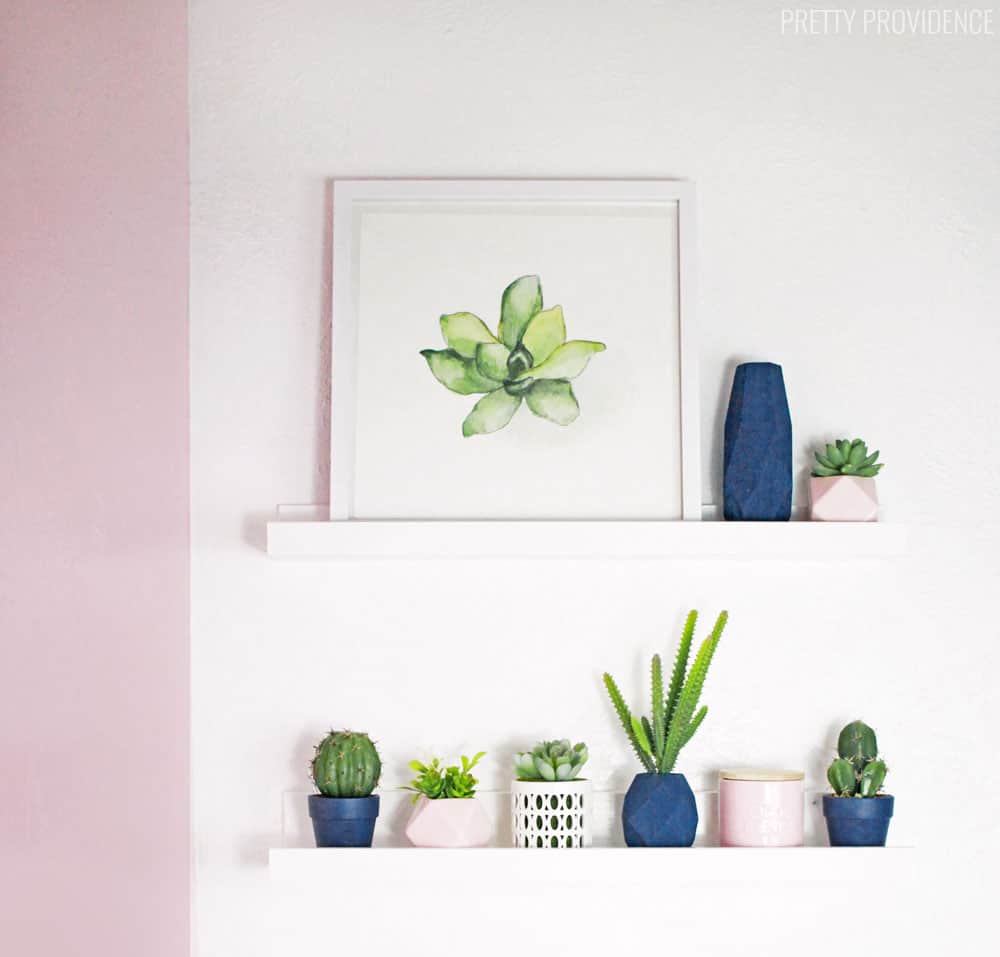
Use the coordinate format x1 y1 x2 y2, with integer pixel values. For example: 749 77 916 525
329 179 702 522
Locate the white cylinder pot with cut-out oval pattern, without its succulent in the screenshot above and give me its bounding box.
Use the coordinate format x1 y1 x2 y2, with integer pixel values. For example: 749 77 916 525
510 781 591 848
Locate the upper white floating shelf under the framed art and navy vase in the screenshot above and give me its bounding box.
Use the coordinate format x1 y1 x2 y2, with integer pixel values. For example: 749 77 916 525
267 520 906 562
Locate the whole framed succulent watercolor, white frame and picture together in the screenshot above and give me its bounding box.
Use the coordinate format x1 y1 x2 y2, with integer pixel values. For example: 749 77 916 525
330 180 701 520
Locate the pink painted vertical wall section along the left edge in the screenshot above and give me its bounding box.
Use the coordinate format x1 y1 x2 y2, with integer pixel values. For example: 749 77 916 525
0 0 190 957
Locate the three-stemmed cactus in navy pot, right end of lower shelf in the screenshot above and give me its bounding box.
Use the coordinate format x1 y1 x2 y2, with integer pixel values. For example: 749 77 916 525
823 721 895 847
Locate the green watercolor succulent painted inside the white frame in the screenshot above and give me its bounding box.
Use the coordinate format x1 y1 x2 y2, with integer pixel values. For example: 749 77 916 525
420 276 605 438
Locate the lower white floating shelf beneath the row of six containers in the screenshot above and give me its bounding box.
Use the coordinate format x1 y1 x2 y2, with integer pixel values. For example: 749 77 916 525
269 847 919 894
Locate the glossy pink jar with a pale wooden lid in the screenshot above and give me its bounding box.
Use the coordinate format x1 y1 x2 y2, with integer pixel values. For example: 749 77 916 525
719 768 805 847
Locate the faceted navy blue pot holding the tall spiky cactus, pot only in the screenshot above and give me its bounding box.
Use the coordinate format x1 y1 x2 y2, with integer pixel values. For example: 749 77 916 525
622 774 698 847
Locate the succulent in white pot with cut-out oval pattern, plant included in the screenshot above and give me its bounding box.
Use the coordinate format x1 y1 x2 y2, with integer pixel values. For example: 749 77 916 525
510 738 590 847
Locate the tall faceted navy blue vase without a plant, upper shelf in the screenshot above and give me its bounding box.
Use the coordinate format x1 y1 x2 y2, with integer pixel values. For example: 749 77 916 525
722 362 792 522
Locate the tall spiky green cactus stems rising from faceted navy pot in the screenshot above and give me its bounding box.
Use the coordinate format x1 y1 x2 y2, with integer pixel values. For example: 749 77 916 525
604 611 729 774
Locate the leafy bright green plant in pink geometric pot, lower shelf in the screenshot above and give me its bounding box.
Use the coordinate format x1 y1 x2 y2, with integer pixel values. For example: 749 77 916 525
406 751 493 847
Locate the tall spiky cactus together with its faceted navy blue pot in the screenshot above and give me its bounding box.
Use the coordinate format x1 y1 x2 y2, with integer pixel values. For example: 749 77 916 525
604 611 729 847
